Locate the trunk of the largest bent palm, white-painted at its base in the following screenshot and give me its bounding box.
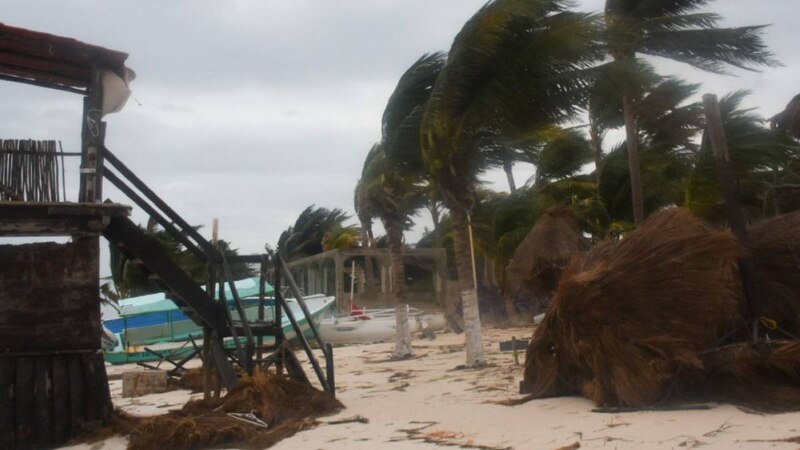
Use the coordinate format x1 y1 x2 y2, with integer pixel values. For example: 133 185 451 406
450 208 486 367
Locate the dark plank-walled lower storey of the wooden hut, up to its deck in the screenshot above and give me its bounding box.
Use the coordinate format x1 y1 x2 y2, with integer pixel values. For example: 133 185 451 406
0 202 130 448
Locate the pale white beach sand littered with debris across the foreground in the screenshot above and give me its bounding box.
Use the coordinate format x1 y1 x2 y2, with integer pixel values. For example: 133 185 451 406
61 328 800 450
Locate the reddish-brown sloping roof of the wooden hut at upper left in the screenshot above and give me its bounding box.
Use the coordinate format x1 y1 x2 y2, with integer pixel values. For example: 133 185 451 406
0 23 128 93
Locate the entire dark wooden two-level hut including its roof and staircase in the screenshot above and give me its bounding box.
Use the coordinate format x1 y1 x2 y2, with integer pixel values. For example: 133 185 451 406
0 24 333 449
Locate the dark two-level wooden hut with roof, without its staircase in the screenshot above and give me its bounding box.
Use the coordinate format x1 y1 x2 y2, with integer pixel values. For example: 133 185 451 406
0 24 130 448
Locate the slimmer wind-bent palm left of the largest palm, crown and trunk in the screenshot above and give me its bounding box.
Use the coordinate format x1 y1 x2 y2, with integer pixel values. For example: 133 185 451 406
359 53 445 358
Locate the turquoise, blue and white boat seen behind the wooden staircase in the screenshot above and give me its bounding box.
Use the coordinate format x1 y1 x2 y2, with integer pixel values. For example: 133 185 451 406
105 286 335 364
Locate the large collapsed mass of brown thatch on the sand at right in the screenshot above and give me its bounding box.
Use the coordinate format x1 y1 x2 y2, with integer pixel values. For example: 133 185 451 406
524 209 800 408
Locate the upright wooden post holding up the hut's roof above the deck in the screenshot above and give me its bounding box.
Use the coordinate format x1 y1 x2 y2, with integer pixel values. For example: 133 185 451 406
78 67 106 203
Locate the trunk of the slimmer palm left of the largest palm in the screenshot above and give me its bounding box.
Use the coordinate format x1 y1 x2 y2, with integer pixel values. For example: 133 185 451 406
384 218 414 359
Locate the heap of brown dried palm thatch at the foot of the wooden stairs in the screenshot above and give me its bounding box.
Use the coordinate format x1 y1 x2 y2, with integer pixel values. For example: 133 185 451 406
128 371 342 450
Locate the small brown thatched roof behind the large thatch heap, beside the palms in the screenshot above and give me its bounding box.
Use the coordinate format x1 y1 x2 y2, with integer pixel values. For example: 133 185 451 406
506 206 590 296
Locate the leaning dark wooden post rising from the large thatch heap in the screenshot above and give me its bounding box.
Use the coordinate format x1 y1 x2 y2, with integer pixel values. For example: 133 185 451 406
703 94 761 342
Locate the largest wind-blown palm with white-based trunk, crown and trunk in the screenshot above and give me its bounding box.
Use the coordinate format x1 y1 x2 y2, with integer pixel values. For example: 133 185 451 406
422 0 597 366
